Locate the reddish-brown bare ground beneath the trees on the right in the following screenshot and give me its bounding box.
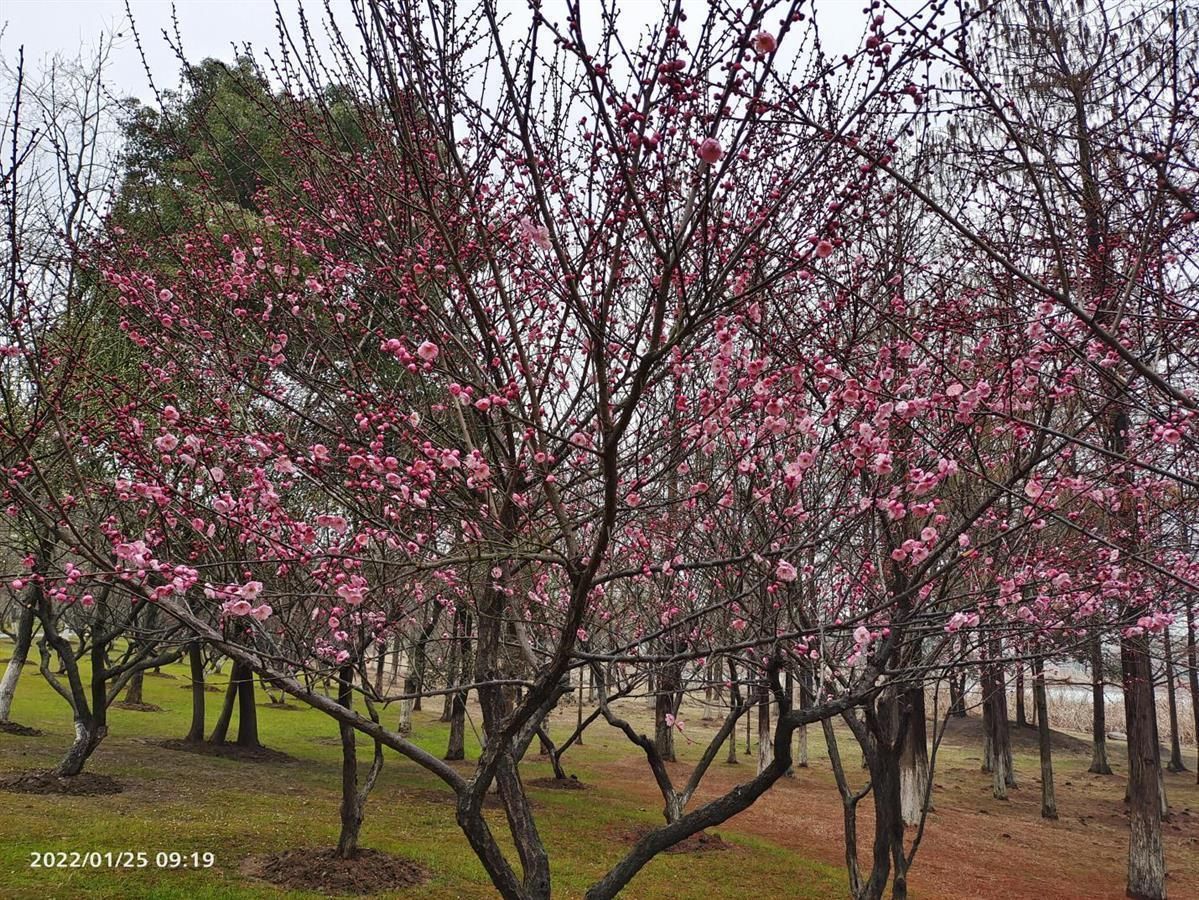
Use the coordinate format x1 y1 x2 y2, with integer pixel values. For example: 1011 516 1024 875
561 709 1199 900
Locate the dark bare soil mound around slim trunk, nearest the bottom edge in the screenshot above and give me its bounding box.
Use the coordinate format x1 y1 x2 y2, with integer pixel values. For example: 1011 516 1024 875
241 848 429 896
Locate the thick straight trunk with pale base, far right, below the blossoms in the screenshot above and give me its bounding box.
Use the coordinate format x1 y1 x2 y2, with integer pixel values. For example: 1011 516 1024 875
1120 635 1165 900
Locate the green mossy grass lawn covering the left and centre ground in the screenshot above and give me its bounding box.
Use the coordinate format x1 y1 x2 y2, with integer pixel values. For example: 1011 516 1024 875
0 645 844 900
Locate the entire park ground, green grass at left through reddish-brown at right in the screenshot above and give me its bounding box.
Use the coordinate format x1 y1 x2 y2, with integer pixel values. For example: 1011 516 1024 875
0 654 1199 900
